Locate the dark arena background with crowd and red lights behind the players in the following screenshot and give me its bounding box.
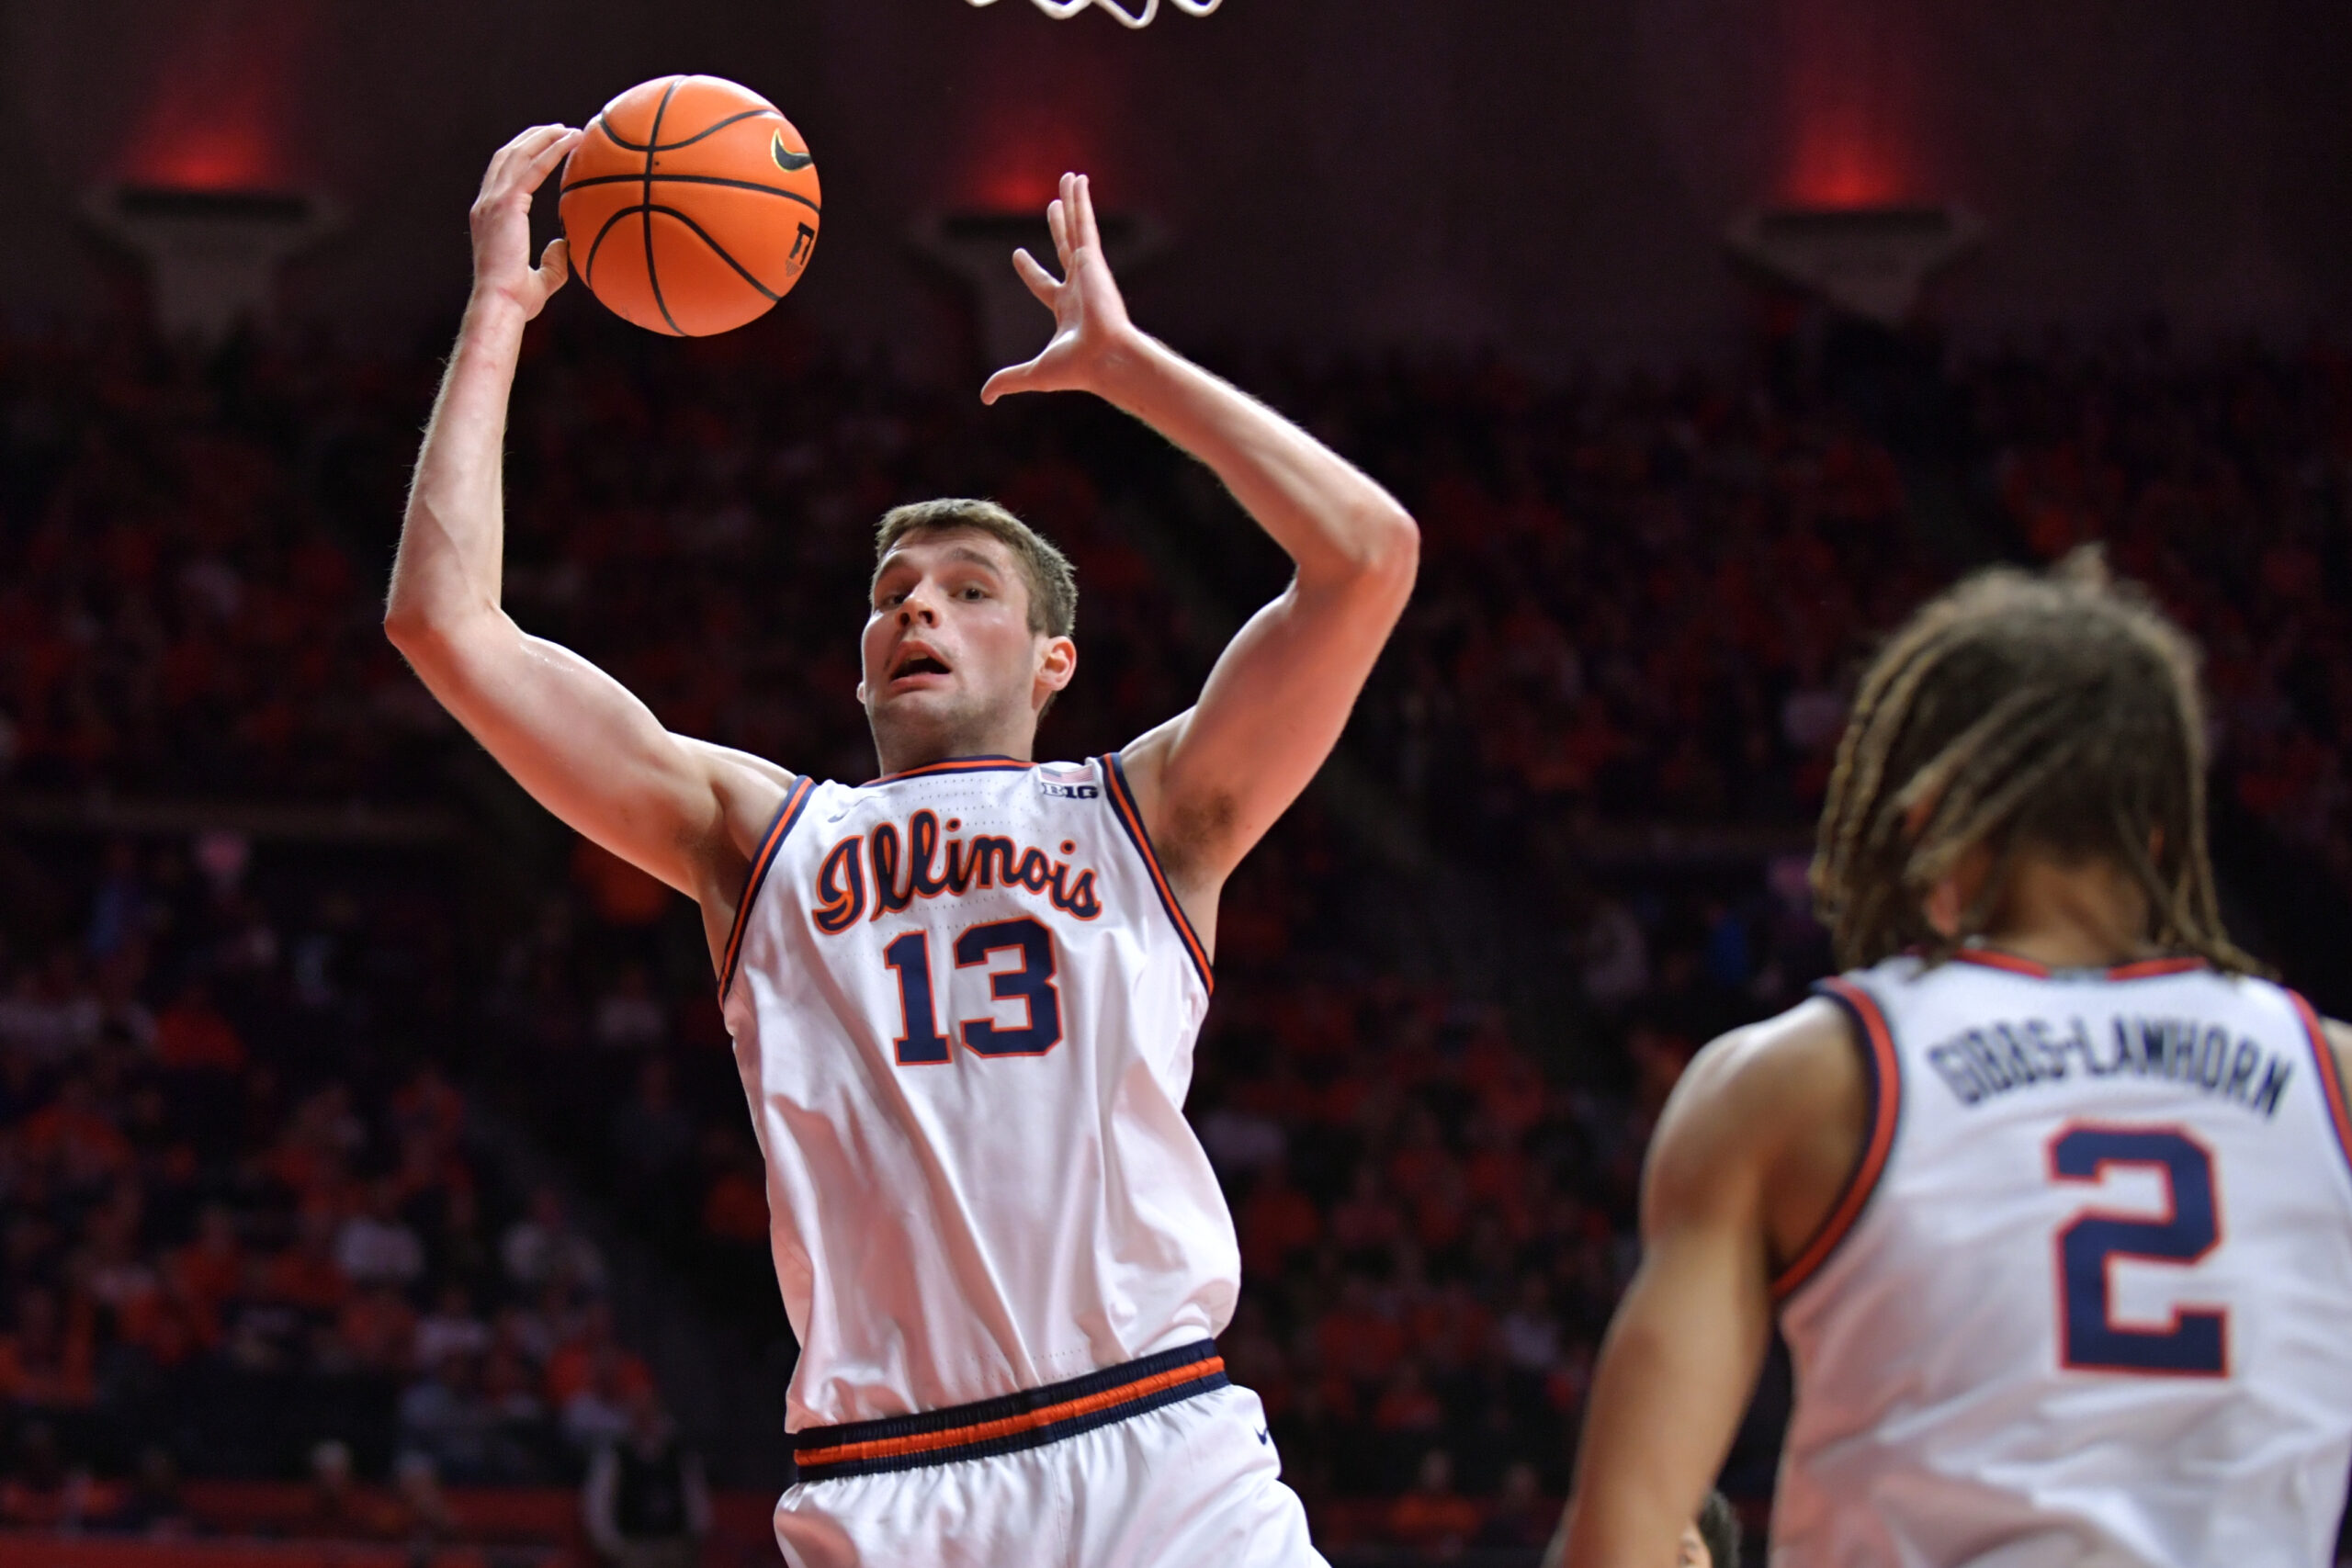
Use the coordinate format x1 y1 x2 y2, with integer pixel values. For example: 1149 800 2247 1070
0 0 2352 1568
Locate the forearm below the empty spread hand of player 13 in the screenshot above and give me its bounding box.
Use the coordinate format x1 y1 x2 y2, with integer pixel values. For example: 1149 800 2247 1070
1103 333 1420 585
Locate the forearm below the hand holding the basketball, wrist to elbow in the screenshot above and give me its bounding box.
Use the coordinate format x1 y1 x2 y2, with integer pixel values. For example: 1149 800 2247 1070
383 294 526 656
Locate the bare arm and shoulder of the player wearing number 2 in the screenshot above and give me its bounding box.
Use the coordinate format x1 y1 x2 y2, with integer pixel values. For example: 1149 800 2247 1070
1555 1001 1865 1568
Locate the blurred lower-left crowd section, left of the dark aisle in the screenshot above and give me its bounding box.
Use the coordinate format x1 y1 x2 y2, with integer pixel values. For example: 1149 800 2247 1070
0 832 700 1535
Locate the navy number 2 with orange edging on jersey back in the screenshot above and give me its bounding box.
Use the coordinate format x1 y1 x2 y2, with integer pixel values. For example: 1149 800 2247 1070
2051 1126 2230 1378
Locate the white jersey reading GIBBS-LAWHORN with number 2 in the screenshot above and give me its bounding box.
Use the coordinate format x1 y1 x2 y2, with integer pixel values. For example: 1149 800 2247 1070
1773 952 2352 1568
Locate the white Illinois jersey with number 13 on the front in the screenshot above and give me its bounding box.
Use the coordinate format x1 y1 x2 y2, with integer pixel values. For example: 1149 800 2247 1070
719 757 1242 1432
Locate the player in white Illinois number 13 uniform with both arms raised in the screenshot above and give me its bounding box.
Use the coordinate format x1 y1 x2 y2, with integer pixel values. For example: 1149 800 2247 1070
386 127 1419 1568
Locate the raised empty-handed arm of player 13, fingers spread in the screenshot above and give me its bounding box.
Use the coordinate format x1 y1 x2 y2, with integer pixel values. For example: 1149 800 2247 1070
981 174 1420 929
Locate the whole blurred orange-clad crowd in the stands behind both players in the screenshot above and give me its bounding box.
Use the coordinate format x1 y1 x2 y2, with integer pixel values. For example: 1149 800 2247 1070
0 312 2352 1551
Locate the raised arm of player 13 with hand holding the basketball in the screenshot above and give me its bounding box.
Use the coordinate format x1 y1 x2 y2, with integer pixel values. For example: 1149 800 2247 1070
383 125 783 942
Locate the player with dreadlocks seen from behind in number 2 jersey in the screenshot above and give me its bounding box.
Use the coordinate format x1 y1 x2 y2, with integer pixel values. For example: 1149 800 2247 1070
1564 558 2352 1568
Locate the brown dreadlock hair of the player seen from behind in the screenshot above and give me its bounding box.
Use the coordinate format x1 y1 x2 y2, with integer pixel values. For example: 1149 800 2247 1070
1811 546 2263 974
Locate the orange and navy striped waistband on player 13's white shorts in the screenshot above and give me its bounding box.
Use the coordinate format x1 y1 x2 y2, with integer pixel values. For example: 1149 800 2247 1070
793 1340 1230 1481
